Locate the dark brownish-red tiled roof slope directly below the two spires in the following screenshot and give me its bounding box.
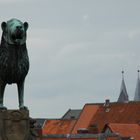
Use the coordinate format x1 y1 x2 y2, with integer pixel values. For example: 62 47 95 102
89 102 140 132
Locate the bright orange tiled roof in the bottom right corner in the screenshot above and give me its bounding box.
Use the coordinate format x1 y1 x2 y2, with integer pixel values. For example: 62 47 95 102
107 123 140 140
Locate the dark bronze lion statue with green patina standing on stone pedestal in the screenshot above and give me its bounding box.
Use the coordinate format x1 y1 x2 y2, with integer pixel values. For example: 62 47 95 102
0 19 29 109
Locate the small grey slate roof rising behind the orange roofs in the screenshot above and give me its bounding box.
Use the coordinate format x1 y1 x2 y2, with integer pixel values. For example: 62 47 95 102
62 109 81 119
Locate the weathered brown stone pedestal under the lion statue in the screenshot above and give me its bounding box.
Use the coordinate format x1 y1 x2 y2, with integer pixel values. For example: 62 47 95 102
0 110 36 140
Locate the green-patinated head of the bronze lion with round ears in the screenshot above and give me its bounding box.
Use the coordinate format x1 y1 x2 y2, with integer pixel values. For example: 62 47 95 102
1 19 28 45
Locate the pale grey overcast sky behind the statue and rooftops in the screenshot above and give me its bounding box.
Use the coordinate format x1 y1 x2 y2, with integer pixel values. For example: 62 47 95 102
0 0 140 118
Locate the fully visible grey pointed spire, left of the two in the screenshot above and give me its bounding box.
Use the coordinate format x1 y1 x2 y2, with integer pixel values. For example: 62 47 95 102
118 71 129 102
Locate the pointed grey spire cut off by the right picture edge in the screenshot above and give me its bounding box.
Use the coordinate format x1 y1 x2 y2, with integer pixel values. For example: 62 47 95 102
134 70 140 101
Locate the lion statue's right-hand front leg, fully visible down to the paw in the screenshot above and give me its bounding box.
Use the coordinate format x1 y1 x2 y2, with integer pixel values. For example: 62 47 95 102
17 81 27 109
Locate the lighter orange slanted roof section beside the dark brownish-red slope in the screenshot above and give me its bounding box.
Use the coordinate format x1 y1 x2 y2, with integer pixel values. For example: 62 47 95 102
72 104 99 134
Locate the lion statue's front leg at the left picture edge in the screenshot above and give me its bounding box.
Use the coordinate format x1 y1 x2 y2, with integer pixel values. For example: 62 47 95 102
0 82 6 109
